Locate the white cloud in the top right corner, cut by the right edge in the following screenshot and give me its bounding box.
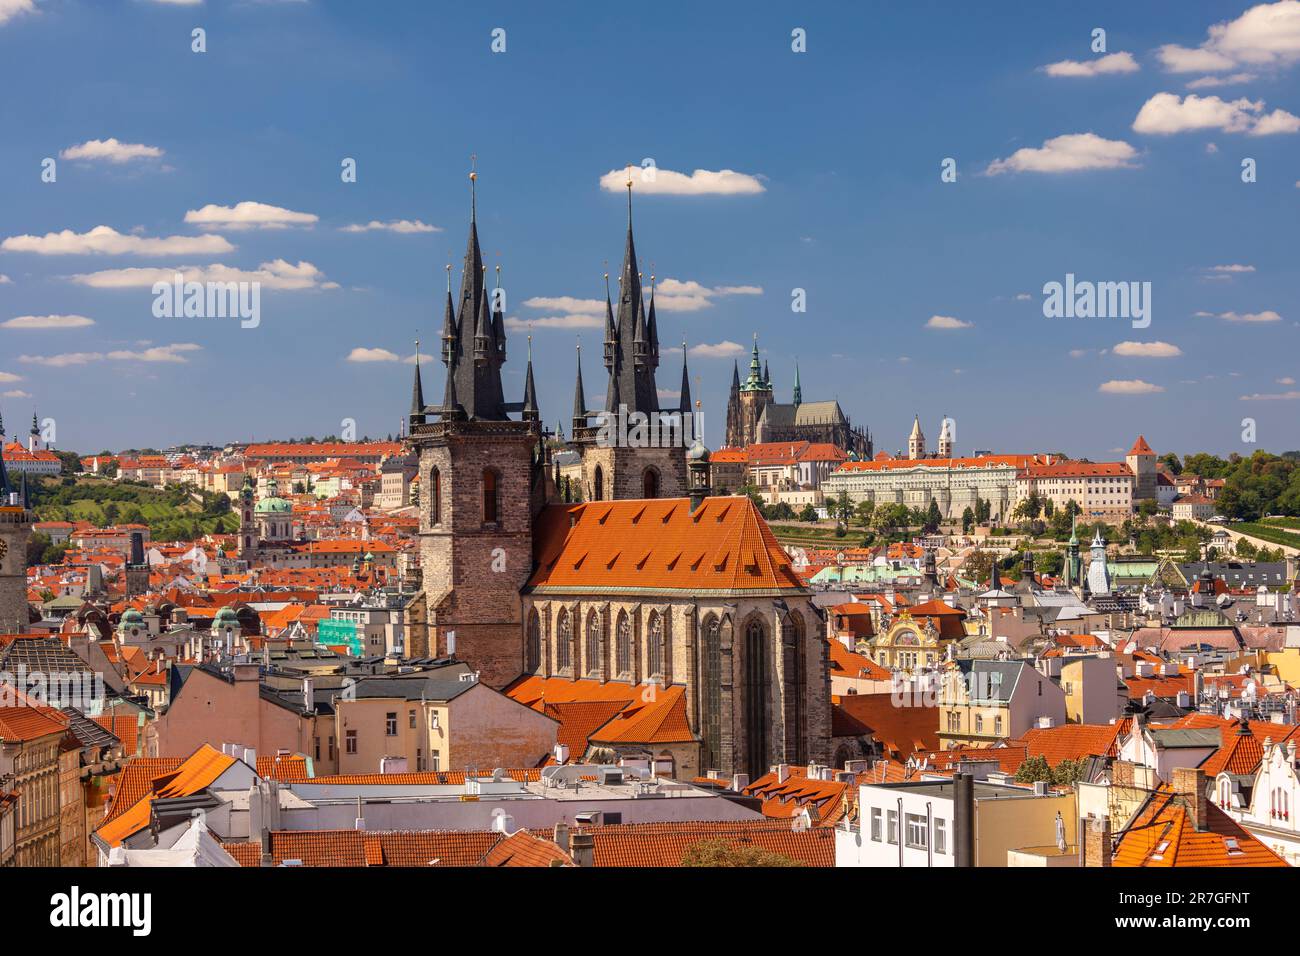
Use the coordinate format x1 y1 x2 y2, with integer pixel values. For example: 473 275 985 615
1157 0 1300 73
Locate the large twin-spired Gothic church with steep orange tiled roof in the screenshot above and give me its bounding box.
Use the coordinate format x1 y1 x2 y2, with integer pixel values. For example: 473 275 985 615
408 174 829 779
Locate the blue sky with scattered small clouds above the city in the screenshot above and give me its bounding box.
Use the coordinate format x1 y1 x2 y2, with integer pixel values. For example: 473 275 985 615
0 0 1300 458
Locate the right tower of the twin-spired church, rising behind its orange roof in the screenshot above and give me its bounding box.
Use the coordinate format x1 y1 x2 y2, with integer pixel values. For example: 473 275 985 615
572 171 689 501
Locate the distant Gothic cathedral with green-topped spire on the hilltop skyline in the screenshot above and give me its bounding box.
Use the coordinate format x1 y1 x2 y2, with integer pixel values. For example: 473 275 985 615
727 333 872 458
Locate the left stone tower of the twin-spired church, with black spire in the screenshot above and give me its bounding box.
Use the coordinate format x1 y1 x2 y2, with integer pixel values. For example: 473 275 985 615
407 172 547 688
